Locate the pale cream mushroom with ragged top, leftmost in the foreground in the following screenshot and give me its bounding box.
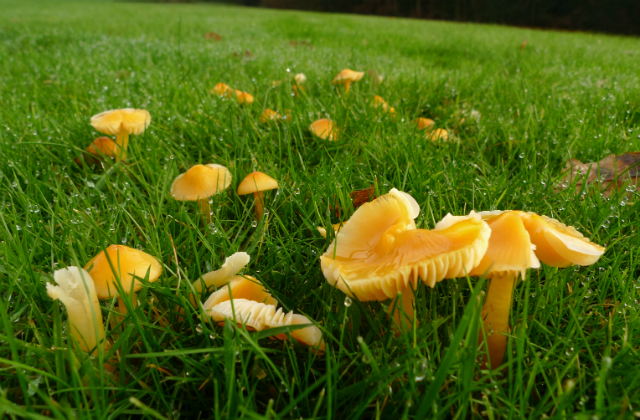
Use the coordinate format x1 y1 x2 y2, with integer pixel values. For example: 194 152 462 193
47 267 104 354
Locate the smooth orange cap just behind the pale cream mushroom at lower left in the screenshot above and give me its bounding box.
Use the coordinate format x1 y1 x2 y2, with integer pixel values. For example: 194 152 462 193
84 245 162 299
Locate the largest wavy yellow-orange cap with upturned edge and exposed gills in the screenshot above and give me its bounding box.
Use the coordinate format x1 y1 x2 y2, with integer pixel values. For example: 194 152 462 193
320 188 491 301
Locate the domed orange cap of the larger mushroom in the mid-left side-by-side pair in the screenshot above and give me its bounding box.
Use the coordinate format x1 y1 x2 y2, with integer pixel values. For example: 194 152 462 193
171 163 231 201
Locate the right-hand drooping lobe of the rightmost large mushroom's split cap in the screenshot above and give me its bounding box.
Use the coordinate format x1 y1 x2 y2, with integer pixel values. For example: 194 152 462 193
480 211 606 268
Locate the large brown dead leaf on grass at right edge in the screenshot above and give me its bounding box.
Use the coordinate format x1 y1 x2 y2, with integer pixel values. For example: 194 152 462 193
558 152 640 197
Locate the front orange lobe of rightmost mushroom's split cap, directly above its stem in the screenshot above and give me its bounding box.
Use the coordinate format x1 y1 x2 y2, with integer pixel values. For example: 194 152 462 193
469 212 540 278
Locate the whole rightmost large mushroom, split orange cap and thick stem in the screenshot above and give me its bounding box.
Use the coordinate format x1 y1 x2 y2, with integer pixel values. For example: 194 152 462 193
469 211 605 368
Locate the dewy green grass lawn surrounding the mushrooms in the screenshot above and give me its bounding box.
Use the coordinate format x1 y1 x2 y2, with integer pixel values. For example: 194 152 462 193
0 0 640 419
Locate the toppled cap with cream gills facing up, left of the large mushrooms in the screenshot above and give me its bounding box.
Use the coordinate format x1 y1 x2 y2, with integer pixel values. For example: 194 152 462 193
207 299 324 350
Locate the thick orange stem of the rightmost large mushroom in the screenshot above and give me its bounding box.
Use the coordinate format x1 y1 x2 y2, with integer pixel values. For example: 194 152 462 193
480 273 517 369
